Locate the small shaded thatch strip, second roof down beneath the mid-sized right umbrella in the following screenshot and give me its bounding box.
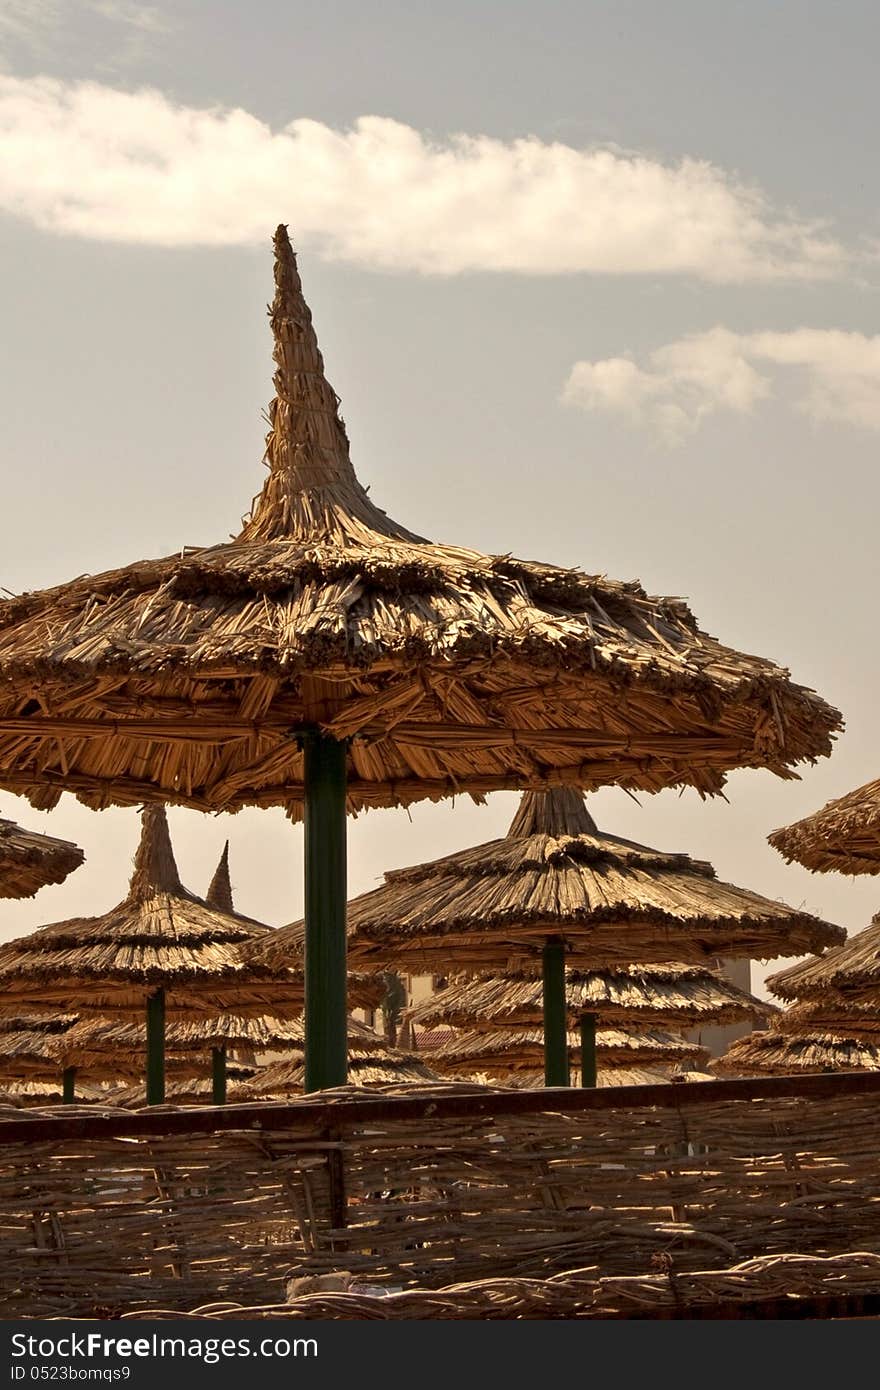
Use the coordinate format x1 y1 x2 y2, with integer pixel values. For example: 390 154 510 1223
431 1029 709 1072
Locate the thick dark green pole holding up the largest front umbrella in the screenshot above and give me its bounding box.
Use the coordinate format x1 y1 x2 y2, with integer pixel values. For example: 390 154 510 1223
303 733 348 1091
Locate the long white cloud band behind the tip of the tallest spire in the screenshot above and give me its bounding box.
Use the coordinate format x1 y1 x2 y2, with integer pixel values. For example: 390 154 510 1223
0 76 845 282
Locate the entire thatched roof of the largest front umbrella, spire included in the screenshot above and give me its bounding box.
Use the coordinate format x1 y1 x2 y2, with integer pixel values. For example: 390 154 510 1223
0 227 841 816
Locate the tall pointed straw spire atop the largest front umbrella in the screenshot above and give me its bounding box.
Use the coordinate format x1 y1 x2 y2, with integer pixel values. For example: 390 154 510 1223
239 225 420 543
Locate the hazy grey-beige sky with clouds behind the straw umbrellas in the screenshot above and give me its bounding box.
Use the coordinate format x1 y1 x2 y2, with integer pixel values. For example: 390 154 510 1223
0 0 880 986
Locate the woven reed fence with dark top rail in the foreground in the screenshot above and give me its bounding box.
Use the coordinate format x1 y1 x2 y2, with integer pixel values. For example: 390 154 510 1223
0 1074 880 1318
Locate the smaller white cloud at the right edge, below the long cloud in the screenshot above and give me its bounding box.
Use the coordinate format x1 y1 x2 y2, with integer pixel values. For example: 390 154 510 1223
562 327 880 445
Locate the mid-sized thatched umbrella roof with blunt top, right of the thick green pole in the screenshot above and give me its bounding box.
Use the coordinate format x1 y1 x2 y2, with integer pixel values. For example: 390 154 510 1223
332 787 845 974
